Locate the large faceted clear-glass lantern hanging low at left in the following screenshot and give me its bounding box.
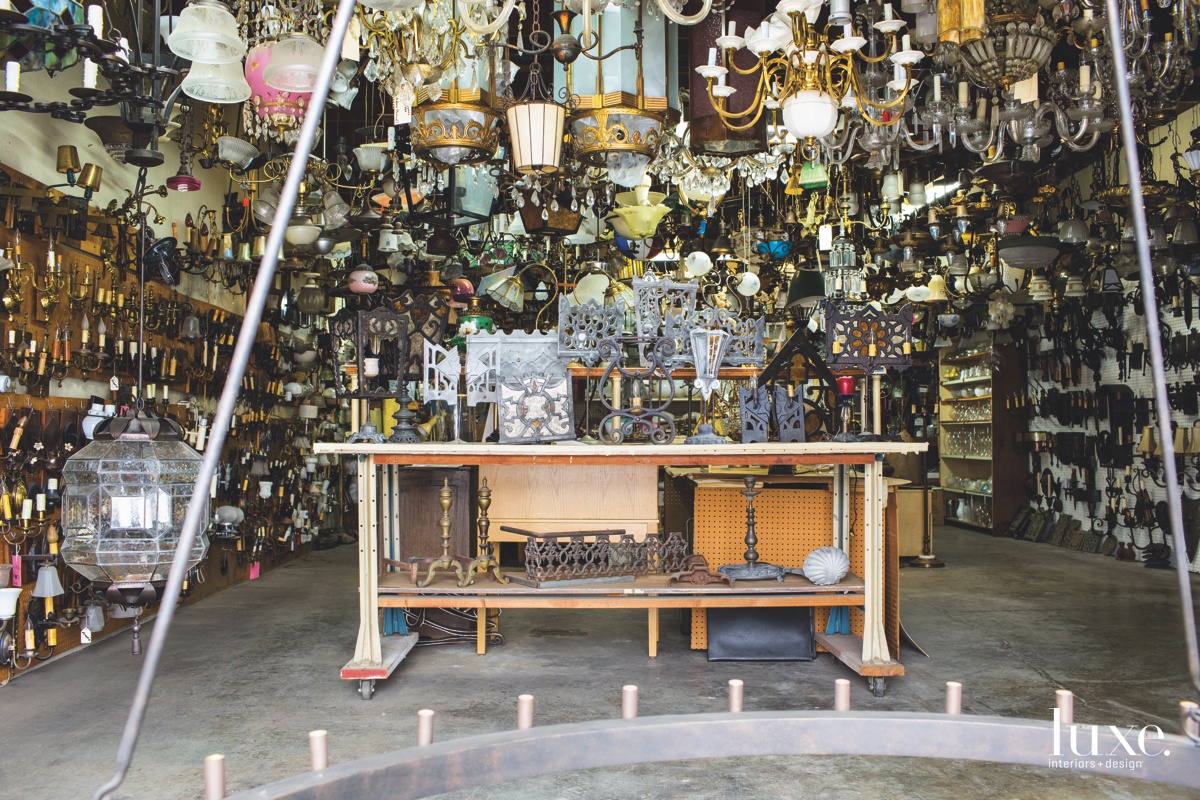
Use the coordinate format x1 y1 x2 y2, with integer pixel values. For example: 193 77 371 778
61 415 209 606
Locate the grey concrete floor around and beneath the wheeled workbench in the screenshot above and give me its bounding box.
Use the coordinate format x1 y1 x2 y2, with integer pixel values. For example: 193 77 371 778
7 529 1200 800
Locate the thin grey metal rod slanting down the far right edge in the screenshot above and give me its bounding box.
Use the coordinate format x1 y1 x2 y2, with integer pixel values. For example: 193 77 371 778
1105 0 1200 692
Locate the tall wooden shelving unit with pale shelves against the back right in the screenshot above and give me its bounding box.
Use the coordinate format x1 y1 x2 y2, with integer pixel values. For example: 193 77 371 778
937 335 1025 534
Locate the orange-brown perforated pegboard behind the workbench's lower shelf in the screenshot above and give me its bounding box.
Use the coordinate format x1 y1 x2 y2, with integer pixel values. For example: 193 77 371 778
691 485 873 650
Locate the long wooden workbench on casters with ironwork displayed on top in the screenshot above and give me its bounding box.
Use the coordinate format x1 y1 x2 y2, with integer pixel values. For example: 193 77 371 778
314 441 926 691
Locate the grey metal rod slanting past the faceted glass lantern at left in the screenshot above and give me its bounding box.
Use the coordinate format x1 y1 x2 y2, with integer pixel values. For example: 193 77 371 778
92 0 355 800
